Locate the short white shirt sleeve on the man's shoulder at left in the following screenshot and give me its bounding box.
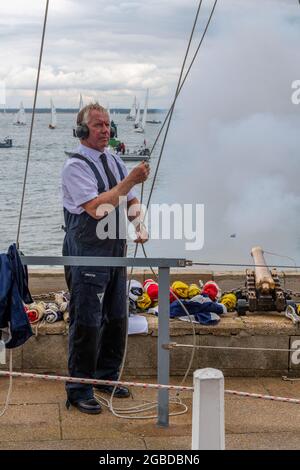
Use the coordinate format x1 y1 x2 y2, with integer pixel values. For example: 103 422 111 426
62 161 98 207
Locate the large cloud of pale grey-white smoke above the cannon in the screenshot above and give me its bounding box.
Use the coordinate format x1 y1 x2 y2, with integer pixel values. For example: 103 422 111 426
143 0 300 264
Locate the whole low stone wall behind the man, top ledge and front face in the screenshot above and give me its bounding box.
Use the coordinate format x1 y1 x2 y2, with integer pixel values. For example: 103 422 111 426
1 268 300 377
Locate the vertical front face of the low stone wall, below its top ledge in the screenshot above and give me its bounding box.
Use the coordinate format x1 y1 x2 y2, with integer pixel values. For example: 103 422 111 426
1 313 300 377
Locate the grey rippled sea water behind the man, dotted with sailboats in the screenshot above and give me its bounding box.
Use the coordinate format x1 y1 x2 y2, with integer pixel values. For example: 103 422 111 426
0 113 164 255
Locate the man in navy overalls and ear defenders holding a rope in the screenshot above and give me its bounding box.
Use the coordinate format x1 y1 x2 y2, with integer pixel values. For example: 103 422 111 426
62 103 149 414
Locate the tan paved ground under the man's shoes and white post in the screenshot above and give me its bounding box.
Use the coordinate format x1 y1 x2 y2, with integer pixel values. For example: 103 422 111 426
0 377 300 450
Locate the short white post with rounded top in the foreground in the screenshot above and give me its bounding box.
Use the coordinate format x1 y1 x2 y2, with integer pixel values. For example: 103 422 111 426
192 368 225 450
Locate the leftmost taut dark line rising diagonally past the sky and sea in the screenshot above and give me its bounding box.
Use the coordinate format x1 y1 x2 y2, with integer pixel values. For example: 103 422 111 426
16 0 49 249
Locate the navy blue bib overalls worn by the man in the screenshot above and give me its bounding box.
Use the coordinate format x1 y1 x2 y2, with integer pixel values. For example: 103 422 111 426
63 154 126 402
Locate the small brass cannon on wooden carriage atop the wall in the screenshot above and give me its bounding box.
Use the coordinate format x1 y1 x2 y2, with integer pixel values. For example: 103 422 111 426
237 246 295 315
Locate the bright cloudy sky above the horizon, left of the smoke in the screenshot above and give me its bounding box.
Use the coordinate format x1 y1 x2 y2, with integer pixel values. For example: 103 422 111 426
0 0 216 107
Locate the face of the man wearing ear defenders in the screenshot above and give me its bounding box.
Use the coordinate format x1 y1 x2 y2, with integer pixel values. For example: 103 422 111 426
83 109 110 152
